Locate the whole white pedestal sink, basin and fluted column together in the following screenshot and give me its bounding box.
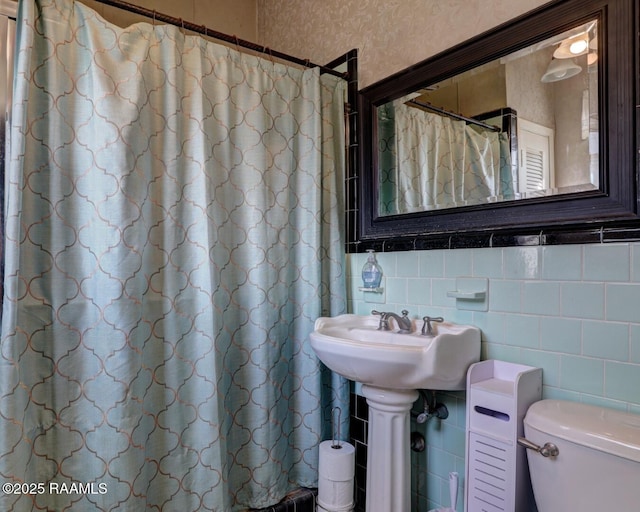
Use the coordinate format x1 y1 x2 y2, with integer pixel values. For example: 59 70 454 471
310 315 480 512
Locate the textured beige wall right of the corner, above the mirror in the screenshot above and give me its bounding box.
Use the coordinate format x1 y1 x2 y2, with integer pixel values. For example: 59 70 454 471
257 0 546 87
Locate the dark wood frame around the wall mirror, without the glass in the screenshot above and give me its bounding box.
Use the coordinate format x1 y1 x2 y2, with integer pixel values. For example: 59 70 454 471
347 0 640 252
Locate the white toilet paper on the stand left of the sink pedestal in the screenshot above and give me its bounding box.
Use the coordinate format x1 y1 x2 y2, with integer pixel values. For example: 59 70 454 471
318 441 356 512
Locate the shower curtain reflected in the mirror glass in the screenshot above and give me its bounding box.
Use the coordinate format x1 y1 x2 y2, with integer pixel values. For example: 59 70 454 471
378 99 517 214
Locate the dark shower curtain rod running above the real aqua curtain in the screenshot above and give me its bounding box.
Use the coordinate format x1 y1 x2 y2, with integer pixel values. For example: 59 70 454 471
95 0 349 78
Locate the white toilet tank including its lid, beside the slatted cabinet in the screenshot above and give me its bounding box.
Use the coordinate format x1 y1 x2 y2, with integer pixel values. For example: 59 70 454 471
524 400 640 512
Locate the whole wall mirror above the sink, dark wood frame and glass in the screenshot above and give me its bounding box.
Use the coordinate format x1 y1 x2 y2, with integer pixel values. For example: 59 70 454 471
358 0 638 240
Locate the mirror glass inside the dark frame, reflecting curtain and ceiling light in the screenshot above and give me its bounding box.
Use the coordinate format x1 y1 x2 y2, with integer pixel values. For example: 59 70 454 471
376 20 599 216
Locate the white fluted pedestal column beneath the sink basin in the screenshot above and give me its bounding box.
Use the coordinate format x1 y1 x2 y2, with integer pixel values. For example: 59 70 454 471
362 384 418 512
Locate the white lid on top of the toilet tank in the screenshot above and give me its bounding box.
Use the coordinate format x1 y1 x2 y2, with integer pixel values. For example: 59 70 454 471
524 400 640 462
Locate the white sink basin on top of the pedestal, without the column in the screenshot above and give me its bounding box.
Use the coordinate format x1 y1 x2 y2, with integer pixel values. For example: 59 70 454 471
310 315 480 390
